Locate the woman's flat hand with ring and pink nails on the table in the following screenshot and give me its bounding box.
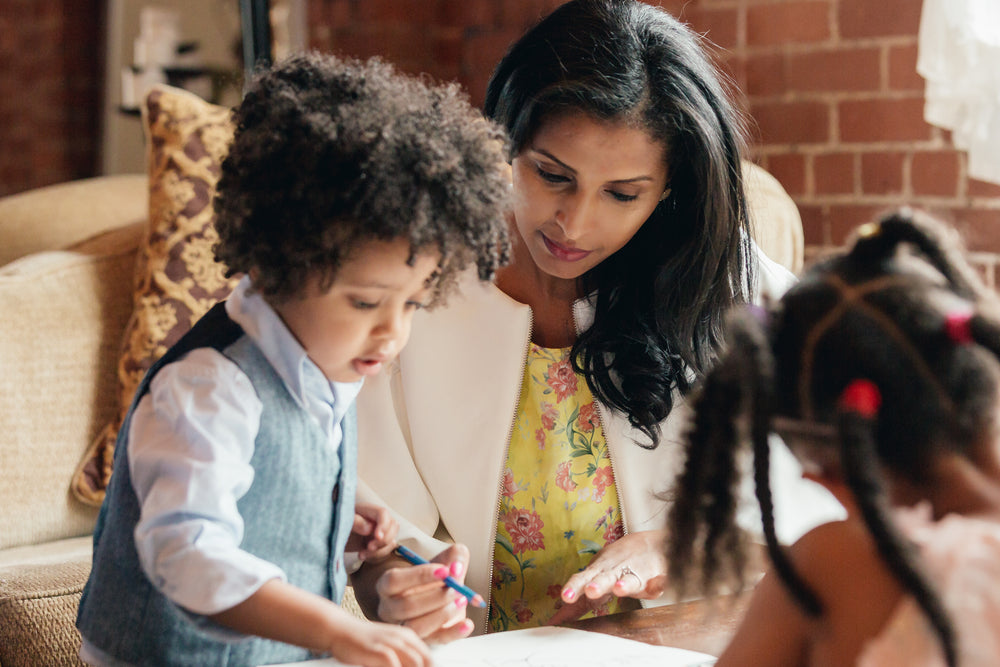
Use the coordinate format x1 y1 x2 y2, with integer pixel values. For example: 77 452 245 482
548 530 667 625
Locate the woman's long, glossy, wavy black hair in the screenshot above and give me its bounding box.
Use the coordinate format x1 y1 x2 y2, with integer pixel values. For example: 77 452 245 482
485 0 754 447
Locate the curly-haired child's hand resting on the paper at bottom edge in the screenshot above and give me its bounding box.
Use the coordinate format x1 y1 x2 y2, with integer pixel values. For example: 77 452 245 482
327 619 432 667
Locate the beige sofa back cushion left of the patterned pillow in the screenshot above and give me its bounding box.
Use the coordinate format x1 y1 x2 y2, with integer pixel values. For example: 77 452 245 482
0 237 137 549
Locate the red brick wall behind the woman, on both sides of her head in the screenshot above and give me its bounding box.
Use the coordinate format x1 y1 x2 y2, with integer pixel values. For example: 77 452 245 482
310 0 1000 278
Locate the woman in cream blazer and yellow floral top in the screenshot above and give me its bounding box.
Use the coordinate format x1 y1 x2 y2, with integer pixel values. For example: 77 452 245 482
348 0 840 641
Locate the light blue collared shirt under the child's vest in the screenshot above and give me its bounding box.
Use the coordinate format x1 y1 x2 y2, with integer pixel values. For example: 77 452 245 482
128 277 361 615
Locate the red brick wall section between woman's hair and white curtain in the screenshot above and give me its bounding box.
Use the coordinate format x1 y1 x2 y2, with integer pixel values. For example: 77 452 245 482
684 0 1000 268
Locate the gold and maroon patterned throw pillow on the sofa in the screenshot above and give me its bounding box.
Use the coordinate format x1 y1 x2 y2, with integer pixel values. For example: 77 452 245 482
72 86 237 505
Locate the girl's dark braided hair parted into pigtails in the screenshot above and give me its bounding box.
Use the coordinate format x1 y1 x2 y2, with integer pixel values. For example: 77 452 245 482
667 209 1000 665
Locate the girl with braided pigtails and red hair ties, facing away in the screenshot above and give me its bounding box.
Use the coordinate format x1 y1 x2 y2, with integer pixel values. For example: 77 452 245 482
668 210 1000 667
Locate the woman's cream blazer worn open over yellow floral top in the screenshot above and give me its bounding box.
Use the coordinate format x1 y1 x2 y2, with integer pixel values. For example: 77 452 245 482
357 245 840 632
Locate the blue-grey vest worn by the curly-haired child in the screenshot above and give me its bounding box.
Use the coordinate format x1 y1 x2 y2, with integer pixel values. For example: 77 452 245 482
77 304 357 666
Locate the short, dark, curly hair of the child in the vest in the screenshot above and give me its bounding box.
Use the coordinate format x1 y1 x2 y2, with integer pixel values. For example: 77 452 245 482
215 53 509 302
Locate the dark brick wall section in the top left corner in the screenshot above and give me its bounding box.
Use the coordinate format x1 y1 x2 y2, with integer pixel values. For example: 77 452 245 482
0 0 104 196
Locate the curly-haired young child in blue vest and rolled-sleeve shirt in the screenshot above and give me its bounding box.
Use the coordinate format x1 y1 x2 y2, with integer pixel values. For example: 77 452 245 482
77 54 509 666
